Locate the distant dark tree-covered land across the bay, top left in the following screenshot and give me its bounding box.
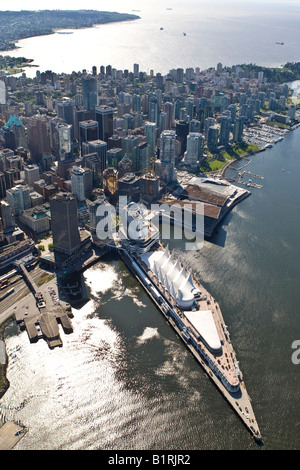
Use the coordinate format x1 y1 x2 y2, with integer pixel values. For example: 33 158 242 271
0 10 140 51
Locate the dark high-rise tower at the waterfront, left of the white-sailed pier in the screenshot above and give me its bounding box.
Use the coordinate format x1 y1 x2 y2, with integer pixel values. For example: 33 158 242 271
50 193 80 256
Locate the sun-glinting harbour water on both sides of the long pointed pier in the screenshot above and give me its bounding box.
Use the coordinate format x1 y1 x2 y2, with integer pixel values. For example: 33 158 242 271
0 129 300 450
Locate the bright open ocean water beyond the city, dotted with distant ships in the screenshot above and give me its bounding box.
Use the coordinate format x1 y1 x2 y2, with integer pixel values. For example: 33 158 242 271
1 0 300 76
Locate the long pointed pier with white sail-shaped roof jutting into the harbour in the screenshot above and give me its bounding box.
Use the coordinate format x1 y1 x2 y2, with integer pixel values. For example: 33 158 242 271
119 203 262 443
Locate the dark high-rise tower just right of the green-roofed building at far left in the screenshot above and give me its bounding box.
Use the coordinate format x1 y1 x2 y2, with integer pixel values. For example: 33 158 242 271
27 115 51 163
